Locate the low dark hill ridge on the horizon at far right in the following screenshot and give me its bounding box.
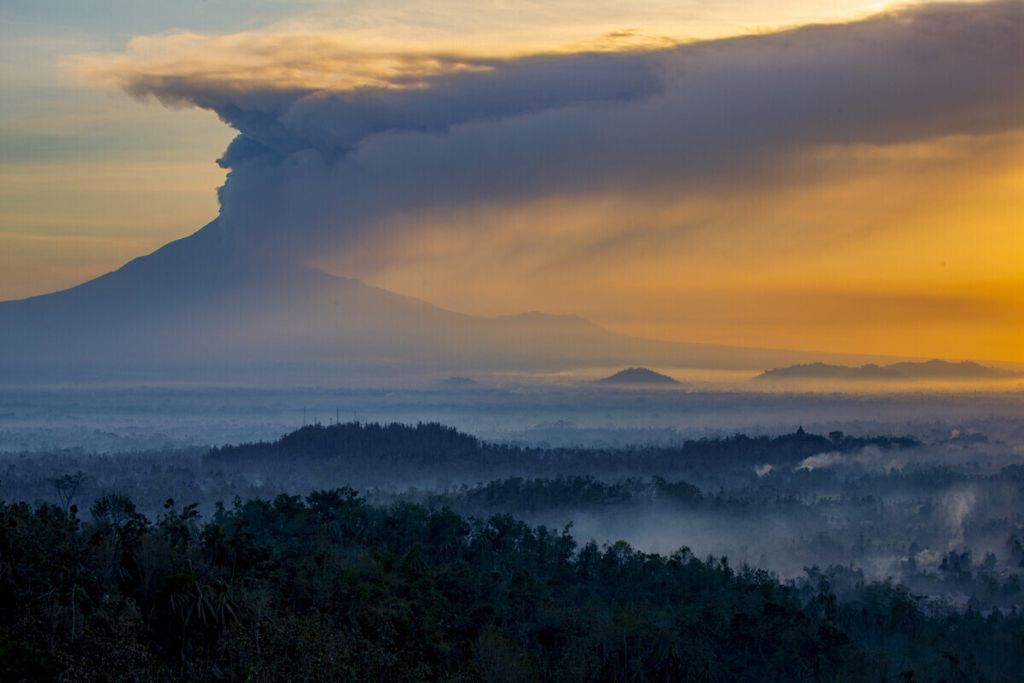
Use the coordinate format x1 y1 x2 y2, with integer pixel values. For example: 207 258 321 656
755 360 1021 382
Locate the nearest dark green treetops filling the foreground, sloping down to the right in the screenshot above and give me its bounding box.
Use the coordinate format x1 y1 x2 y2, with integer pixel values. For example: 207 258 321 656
0 493 1024 682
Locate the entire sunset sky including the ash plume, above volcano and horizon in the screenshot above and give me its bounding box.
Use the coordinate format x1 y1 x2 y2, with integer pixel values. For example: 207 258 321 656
0 0 1024 361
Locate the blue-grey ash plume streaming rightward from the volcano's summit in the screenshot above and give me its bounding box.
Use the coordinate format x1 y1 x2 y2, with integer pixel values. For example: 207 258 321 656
74 2 1024 262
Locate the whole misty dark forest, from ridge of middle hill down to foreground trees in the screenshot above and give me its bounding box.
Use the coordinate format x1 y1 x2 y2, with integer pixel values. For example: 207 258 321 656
0 423 1024 682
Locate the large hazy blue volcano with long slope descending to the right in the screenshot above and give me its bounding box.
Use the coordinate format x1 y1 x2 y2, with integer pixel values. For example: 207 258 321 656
0 219 897 385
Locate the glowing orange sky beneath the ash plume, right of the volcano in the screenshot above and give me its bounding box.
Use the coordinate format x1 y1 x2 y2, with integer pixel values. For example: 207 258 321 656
322 133 1024 361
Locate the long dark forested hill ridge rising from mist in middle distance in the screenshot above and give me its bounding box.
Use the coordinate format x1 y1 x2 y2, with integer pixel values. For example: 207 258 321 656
209 423 916 476
